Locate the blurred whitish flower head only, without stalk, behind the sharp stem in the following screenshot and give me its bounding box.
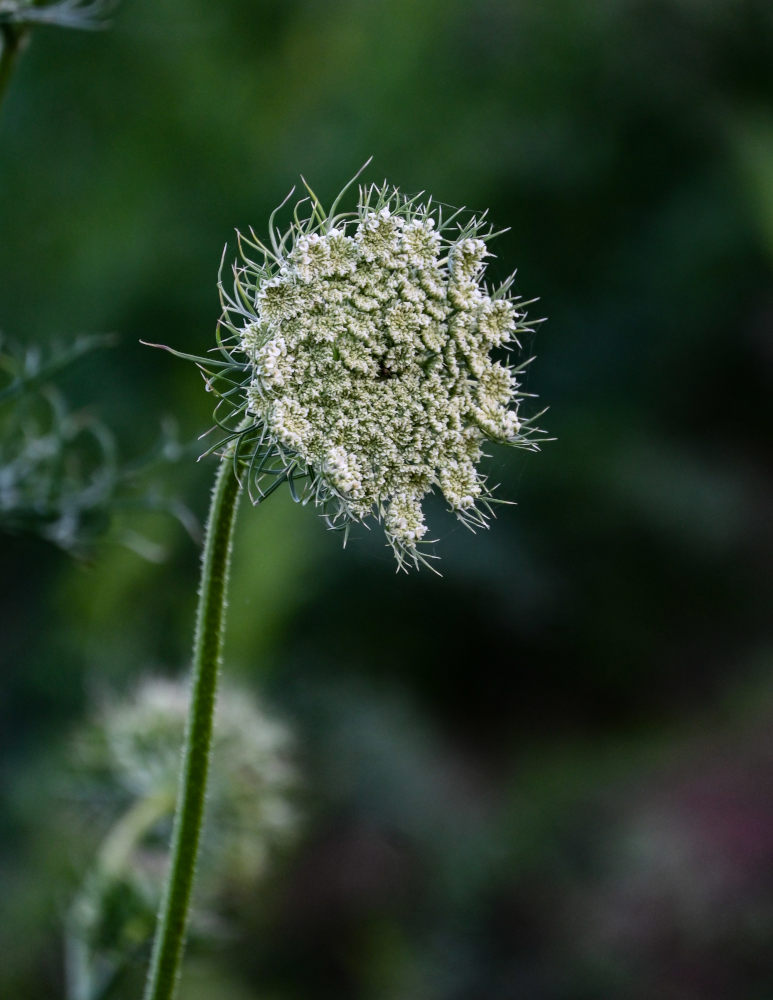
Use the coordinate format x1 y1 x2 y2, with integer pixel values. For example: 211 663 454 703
82 677 299 883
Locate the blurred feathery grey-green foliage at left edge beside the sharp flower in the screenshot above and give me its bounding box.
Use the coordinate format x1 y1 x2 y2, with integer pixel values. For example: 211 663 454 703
0 335 193 560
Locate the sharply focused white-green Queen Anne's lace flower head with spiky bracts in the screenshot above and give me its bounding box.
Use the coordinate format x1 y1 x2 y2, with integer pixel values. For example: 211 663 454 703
202 168 539 566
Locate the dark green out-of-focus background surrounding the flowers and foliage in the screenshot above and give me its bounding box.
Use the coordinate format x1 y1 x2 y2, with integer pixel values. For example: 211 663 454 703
0 0 773 1000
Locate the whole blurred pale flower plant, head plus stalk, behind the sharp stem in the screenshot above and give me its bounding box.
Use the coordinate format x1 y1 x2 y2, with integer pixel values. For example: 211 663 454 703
66 677 300 1000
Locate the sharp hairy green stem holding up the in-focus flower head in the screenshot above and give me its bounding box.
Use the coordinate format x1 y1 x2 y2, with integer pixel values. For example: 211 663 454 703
145 452 241 1000
